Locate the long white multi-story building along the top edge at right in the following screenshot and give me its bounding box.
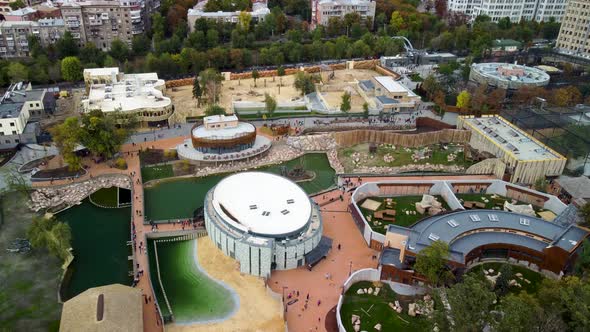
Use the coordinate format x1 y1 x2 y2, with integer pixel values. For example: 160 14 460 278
447 0 567 23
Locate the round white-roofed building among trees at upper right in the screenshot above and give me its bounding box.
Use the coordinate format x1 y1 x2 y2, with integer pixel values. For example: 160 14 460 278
469 62 549 90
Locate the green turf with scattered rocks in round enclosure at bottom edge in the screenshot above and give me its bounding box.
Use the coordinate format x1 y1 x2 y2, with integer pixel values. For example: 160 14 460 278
340 281 428 331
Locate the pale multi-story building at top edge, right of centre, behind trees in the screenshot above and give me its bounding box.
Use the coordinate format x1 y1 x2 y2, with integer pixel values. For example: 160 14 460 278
311 0 376 26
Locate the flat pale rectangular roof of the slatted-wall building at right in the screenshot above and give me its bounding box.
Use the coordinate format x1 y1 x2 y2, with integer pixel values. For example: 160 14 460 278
463 115 565 160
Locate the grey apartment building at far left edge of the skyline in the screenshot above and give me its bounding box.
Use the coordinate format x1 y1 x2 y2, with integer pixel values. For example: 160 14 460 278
0 18 65 58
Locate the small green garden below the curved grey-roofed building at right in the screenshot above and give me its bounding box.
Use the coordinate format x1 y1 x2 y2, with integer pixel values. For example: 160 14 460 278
469 262 544 295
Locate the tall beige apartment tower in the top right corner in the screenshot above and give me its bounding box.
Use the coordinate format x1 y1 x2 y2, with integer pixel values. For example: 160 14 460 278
555 0 590 58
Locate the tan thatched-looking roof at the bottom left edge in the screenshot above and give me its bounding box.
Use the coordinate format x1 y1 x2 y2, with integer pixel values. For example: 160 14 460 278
59 284 143 332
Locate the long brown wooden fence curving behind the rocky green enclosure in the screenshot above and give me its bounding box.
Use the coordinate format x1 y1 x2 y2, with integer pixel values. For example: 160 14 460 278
333 129 471 148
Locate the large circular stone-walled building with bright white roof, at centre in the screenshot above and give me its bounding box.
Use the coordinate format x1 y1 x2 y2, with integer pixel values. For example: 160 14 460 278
204 172 323 277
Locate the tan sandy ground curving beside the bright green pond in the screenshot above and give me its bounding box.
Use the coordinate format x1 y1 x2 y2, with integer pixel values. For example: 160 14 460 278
166 237 285 332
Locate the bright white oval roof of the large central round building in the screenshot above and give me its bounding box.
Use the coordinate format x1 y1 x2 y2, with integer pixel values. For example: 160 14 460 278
212 172 312 237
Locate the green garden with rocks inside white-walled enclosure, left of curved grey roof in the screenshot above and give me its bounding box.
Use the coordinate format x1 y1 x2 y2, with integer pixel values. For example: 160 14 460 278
357 195 450 234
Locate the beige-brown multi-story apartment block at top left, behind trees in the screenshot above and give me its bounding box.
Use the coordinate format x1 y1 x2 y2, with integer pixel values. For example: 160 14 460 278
61 0 148 51
